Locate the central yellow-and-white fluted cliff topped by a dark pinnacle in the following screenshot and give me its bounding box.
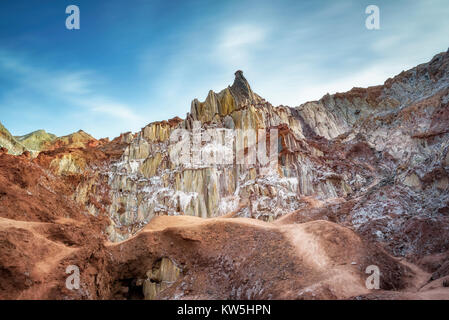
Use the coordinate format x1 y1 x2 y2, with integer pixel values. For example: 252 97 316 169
90 71 356 240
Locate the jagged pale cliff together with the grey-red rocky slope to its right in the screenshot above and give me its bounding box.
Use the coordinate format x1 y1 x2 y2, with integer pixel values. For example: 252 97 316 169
71 52 449 254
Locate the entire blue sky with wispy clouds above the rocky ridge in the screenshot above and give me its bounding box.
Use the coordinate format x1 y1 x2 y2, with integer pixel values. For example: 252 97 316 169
0 0 449 138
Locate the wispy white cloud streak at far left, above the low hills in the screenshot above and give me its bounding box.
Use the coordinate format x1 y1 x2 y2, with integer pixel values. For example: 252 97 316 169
0 51 145 137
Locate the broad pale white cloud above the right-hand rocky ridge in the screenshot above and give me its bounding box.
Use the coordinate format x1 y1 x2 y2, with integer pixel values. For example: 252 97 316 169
206 0 449 106
